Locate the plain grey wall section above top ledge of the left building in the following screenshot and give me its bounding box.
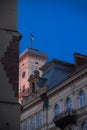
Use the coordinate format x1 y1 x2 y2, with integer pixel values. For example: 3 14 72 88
0 0 18 30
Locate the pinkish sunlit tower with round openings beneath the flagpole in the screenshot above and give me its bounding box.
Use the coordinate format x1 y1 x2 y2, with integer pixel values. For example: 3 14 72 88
19 48 47 102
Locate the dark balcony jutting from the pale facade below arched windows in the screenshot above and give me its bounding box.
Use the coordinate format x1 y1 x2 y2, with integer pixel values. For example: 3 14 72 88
53 109 77 130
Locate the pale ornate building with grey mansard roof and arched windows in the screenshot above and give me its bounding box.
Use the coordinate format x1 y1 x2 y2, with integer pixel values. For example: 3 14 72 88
21 53 87 130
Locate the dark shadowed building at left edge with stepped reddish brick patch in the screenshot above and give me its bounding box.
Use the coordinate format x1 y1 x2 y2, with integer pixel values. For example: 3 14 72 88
0 0 21 130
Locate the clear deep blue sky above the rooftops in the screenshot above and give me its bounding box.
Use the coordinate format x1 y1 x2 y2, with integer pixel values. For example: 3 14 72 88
18 0 87 63
